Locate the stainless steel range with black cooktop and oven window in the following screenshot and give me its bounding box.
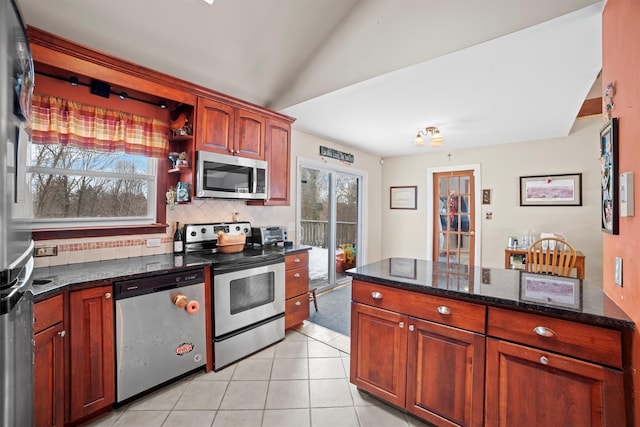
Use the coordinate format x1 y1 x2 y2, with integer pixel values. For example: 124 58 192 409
183 222 285 370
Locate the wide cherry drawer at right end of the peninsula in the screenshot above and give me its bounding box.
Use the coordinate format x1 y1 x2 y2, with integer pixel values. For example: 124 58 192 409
487 307 622 368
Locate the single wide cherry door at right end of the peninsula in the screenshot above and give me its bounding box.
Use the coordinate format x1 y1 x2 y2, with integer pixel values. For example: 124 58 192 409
486 338 626 427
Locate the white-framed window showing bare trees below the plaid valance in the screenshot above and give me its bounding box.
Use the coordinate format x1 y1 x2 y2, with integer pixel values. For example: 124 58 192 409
29 144 157 228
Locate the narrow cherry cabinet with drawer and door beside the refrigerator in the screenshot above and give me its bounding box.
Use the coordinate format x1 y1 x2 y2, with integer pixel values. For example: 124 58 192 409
33 295 65 427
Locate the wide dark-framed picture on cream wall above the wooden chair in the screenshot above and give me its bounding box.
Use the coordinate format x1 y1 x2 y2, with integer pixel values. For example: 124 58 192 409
520 173 582 206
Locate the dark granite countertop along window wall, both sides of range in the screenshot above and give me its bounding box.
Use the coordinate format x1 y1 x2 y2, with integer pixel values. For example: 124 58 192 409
31 245 311 301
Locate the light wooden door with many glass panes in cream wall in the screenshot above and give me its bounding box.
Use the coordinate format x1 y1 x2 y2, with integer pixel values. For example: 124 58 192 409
427 165 481 266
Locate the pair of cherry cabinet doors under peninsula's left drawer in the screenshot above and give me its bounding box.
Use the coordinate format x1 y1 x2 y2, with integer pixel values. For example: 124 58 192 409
351 303 485 426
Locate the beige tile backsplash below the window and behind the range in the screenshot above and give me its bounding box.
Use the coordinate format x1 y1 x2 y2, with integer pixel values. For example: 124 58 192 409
35 200 293 267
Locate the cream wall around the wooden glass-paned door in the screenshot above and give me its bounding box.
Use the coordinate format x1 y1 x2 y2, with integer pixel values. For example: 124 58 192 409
382 117 603 278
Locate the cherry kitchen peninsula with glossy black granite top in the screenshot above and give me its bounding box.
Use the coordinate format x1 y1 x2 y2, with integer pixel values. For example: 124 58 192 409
346 258 635 426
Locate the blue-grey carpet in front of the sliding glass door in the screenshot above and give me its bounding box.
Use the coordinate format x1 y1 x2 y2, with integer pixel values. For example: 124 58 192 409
309 284 351 336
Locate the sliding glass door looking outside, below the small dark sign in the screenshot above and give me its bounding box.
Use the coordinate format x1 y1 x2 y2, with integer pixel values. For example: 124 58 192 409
297 160 364 292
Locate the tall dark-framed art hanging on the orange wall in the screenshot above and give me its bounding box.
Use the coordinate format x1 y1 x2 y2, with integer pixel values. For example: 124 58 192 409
600 118 619 234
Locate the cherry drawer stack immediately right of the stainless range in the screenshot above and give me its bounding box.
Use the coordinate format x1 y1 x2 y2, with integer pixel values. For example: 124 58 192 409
284 252 309 329
